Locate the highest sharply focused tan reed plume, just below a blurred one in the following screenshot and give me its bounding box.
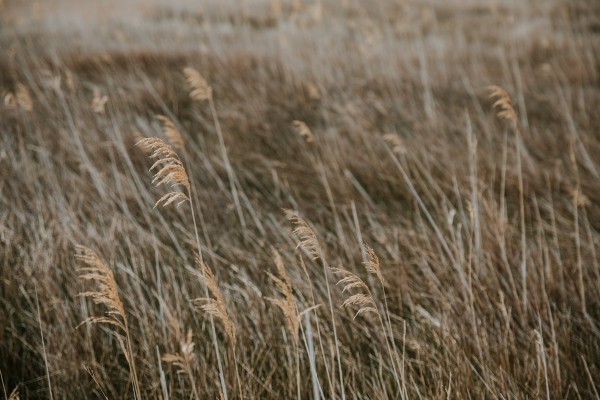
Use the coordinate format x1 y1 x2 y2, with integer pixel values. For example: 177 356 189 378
136 137 190 207
